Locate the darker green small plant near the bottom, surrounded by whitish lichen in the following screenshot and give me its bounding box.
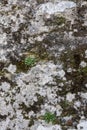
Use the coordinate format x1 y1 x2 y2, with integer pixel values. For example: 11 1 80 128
43 112 56 124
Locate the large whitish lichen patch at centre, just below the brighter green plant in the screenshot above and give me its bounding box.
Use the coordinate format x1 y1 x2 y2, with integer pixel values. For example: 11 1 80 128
16 62 57 105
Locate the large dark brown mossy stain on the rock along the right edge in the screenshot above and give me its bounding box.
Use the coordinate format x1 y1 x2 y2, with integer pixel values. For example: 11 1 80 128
57 44 87 95
